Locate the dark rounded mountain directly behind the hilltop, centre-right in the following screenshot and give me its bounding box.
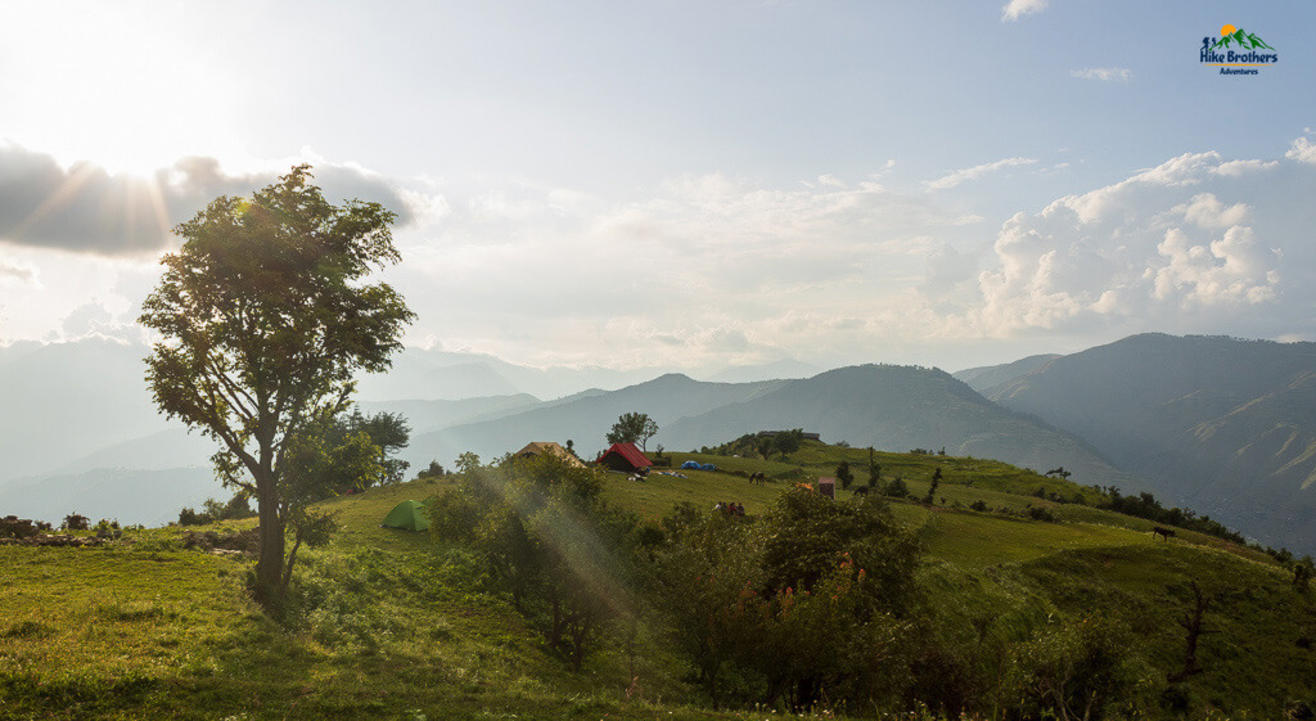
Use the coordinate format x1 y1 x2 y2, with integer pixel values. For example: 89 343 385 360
658 366 1137 487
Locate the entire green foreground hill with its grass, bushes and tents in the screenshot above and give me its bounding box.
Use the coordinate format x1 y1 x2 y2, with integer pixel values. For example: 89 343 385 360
0 431 1316 718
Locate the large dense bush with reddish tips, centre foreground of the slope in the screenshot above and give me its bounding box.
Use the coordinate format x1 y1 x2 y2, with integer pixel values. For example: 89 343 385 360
654 489 917 709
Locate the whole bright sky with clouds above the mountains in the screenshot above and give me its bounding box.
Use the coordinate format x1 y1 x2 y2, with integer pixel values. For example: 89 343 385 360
0 0 1316 370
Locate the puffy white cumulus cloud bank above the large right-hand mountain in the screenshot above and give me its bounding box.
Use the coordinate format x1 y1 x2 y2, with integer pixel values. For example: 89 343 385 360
965 151 1316 337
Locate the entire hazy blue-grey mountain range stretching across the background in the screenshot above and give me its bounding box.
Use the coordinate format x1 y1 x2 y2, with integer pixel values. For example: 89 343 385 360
0 334 1316 551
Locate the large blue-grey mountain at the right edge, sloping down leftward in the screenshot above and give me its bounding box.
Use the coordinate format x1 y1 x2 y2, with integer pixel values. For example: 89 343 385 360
983 334 1316 551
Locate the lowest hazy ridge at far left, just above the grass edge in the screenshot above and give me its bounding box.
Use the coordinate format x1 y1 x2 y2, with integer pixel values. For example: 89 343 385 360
0 468 223 526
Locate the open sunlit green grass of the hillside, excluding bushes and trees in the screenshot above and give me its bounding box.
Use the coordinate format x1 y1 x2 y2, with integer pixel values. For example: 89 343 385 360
0 443 1316 720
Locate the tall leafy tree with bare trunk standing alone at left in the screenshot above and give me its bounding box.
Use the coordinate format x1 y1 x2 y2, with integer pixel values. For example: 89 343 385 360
141 166 415 610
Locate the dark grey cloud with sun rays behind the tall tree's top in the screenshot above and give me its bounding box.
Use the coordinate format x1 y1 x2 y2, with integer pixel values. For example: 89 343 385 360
0 145 412 255
